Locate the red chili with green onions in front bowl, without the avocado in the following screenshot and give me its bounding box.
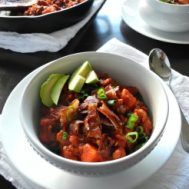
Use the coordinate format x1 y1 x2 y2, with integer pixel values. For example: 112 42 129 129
39 75 153 162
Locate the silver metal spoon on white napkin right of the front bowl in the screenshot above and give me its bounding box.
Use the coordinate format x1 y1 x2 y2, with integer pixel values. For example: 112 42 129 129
149 48 189 152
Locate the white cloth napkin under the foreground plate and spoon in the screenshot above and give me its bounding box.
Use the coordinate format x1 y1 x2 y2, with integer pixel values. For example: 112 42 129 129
0 39 189 189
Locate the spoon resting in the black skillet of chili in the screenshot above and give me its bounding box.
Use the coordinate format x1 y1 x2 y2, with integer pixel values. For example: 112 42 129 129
0 0 37 10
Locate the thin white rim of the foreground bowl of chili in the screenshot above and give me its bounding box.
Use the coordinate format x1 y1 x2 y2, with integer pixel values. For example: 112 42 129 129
19 51 169 168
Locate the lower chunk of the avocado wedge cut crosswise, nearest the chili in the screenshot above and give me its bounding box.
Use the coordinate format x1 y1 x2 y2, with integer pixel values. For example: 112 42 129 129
68 75 86 93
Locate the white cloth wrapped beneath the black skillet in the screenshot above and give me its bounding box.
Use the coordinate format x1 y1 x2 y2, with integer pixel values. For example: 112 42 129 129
0 0 105 53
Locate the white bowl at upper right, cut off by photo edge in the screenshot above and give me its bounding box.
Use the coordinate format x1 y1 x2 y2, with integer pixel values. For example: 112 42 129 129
139 0 189 32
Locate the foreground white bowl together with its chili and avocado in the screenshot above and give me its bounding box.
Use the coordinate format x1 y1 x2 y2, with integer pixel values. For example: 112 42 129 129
20 52 168 175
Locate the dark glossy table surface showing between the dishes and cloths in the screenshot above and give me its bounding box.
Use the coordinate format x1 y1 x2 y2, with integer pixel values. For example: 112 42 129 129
0 0 189 189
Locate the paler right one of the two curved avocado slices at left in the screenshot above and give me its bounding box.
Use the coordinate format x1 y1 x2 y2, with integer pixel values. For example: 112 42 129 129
50 75 69 105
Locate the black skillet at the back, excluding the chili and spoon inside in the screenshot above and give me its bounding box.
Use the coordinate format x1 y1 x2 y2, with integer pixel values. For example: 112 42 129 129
0 0 94 33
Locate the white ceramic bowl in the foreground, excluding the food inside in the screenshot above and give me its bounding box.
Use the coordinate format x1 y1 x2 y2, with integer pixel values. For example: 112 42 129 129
20 52 168 175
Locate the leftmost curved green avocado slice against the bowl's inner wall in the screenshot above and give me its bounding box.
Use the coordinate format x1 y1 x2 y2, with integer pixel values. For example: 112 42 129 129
40 74 62 107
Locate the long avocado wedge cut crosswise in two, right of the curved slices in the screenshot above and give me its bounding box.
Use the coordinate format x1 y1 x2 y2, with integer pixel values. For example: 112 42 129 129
68 61 92 92
